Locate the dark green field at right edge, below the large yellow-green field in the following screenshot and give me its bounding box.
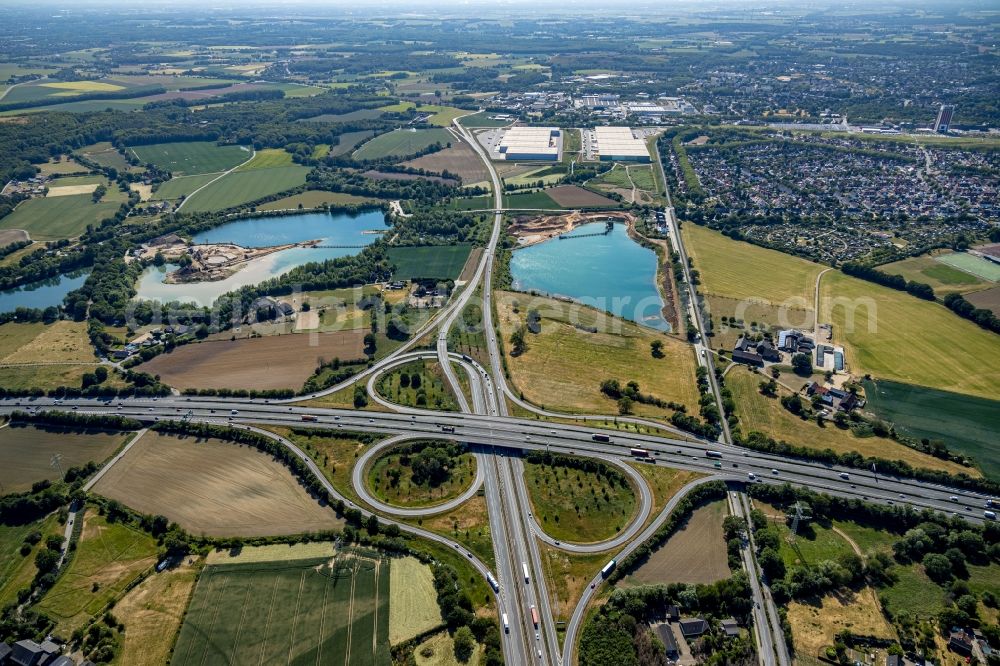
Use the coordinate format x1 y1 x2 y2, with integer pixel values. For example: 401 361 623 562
865 381 1000 480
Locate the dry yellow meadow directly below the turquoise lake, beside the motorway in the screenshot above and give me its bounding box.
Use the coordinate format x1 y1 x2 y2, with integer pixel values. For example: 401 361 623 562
495 292 698 417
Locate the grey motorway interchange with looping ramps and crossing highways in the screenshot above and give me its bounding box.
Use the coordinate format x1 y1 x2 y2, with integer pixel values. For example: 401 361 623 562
0 120 988 666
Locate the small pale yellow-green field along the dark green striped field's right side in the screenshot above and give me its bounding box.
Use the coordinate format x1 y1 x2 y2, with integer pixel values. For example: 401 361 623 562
389 557 444 645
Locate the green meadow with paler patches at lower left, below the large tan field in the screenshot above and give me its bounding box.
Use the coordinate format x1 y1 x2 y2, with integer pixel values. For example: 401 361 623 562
37 508 156 636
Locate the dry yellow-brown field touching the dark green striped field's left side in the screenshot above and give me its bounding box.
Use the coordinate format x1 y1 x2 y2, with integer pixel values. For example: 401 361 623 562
114 562 198 666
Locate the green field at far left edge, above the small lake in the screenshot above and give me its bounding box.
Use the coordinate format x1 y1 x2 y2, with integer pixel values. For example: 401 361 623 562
0 190 120 240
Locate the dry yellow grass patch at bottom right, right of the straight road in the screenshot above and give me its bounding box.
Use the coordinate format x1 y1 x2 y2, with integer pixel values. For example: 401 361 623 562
788 588 896 657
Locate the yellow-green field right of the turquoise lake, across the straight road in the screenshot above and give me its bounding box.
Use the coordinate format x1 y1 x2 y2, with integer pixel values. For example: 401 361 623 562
681 222 825 306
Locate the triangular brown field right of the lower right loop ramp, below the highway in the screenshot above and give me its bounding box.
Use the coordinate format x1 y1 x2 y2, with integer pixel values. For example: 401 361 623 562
631 500 730 585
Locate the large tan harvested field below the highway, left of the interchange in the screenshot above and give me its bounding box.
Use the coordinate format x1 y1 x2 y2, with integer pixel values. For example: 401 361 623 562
94 432 343 536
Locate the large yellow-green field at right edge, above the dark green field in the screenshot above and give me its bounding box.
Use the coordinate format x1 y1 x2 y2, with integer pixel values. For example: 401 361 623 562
819 271 1000 398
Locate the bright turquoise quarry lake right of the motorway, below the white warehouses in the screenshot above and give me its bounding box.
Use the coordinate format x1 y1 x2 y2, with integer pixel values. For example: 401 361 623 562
510 223 670 331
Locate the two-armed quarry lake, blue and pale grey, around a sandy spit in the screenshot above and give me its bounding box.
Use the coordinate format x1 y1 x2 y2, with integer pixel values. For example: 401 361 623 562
136 210 388 306
